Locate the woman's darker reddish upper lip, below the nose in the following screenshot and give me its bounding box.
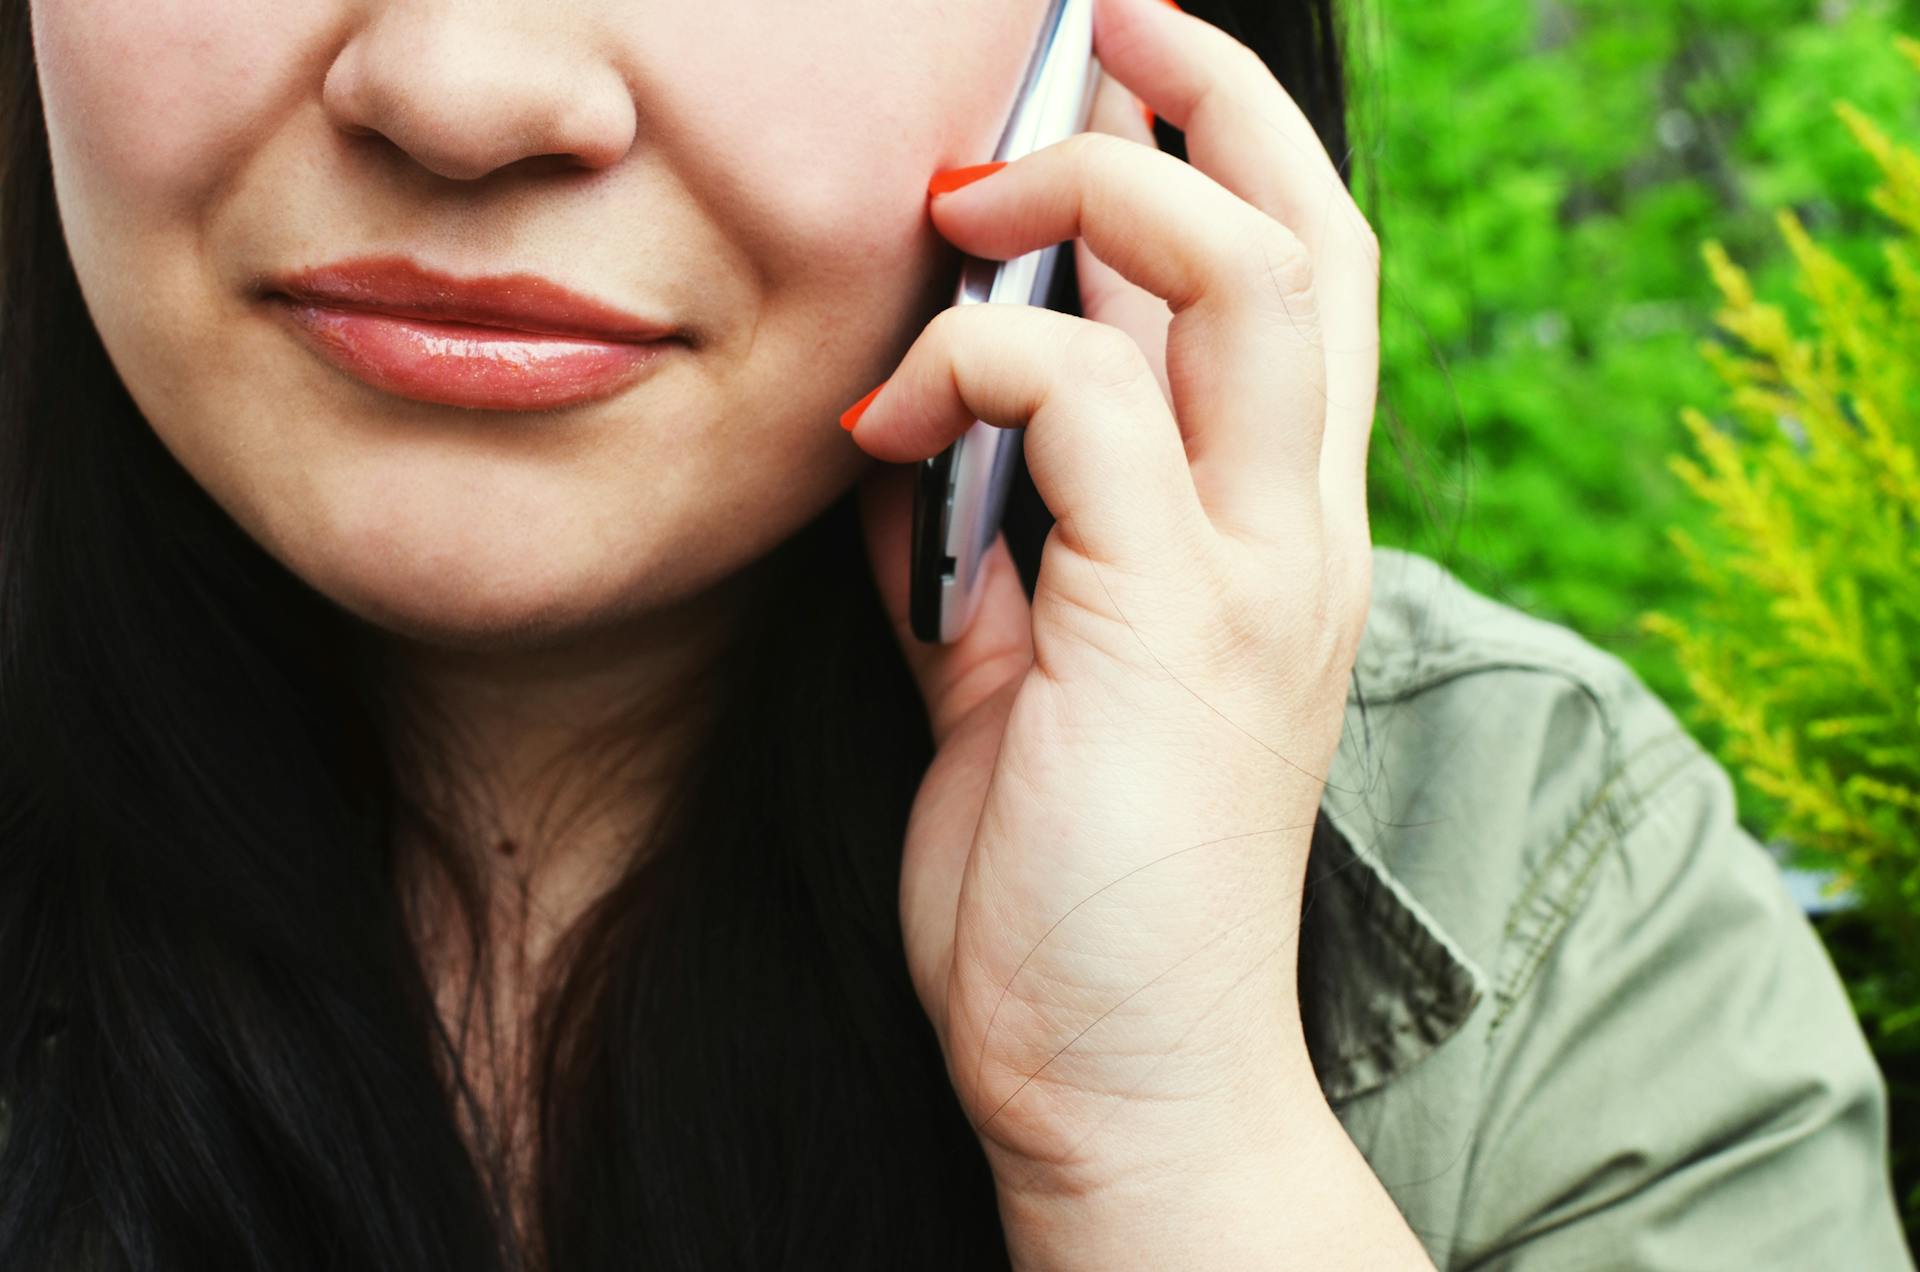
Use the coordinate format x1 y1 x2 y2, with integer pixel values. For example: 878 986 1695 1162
267 256 674 342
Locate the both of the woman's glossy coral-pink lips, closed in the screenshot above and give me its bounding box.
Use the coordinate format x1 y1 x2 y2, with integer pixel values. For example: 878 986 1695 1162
269 256 678 411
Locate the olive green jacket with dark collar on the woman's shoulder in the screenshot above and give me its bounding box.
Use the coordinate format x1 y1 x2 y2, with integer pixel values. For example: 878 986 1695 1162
1300 548 1914 1272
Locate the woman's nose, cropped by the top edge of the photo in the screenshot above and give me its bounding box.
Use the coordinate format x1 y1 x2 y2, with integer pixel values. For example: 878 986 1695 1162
321 0 636 181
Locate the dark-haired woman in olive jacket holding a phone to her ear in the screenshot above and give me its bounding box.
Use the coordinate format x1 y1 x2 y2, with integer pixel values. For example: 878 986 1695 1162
0 0 1905 1270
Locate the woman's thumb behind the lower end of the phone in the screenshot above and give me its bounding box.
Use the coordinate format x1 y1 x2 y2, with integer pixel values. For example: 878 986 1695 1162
856 463 1033 747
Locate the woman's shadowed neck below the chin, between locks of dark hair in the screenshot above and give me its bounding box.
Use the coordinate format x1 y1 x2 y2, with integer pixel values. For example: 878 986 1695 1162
382 576 747 966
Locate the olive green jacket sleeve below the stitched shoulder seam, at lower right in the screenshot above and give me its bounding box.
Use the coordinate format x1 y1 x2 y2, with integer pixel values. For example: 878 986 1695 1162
1446 682 1914 1272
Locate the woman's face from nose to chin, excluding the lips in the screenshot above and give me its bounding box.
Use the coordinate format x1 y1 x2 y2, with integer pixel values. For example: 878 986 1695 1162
33 0 1044 648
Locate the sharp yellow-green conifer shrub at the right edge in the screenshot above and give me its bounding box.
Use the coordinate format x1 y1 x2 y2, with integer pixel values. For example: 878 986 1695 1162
1644 37 1920 1237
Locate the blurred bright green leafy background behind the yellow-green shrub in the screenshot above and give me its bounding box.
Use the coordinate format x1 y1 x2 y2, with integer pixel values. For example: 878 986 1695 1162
1348 0 1920 1237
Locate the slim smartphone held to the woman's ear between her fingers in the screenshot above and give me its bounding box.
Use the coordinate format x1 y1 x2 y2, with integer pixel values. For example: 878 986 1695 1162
908 0 1100 644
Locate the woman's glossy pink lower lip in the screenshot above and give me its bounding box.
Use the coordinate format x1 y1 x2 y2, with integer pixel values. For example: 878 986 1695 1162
284 300 672 411
